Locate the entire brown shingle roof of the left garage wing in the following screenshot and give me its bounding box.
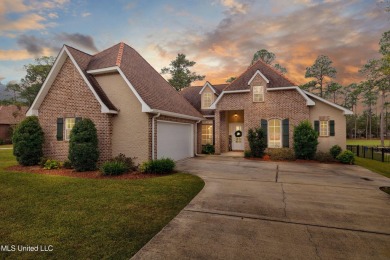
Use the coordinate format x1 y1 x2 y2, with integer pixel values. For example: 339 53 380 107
68 42 202 118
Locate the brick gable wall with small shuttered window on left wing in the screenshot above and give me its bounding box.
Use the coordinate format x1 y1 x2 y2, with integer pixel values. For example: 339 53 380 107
39 58 112 162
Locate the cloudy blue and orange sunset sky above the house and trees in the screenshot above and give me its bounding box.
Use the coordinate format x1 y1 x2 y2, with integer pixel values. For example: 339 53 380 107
0 0 390 85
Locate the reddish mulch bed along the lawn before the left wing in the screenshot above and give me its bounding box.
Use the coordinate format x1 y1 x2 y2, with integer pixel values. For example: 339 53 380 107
7 165 161 180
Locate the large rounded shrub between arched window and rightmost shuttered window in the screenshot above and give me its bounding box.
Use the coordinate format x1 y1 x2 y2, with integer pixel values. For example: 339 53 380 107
294 121 318 160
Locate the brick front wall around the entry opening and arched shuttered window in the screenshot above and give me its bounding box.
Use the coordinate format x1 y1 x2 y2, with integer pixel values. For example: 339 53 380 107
215 75 310 153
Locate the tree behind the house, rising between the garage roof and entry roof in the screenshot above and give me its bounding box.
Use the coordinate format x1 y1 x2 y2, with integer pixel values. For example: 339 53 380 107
161 53 205 91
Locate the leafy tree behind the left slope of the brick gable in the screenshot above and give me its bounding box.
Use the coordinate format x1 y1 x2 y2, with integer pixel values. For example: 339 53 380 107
18 56 55 106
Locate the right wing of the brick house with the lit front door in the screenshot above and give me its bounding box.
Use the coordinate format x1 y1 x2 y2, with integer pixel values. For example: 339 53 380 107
181 60 353 154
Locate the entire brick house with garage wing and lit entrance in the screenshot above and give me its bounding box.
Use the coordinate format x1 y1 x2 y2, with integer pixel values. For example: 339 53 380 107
27 43 352 163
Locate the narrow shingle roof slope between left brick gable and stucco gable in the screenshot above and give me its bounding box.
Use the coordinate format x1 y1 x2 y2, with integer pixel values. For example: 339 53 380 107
66 46 118 111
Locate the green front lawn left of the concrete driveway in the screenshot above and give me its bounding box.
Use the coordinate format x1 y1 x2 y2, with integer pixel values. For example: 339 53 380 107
0 146 204 259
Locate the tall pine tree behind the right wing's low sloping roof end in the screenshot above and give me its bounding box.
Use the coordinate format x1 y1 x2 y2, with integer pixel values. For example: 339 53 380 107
302 55 337 97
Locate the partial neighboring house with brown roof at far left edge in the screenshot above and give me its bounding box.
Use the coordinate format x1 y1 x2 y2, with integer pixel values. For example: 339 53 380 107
0 105 28 143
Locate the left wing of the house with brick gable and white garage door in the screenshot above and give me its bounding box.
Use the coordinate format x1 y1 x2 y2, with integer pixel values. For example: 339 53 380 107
27 43 204 163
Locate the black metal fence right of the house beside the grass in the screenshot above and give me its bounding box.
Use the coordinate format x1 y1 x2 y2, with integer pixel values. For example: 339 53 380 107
347 145 390 162
